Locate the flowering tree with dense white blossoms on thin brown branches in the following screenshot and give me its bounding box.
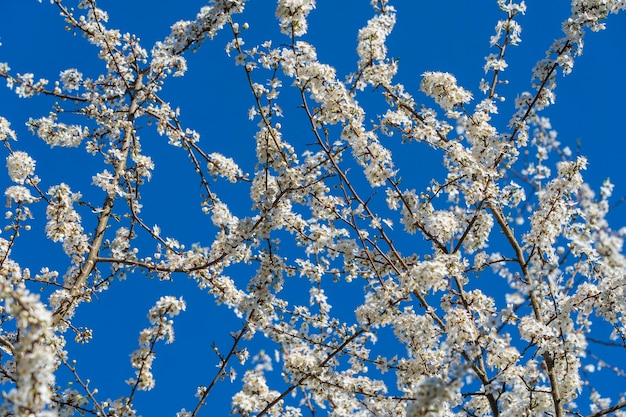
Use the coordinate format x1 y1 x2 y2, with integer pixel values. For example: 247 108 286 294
0 0 626 417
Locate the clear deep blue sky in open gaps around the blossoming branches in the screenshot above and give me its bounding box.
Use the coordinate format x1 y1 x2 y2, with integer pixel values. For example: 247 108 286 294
0 0 626 416
